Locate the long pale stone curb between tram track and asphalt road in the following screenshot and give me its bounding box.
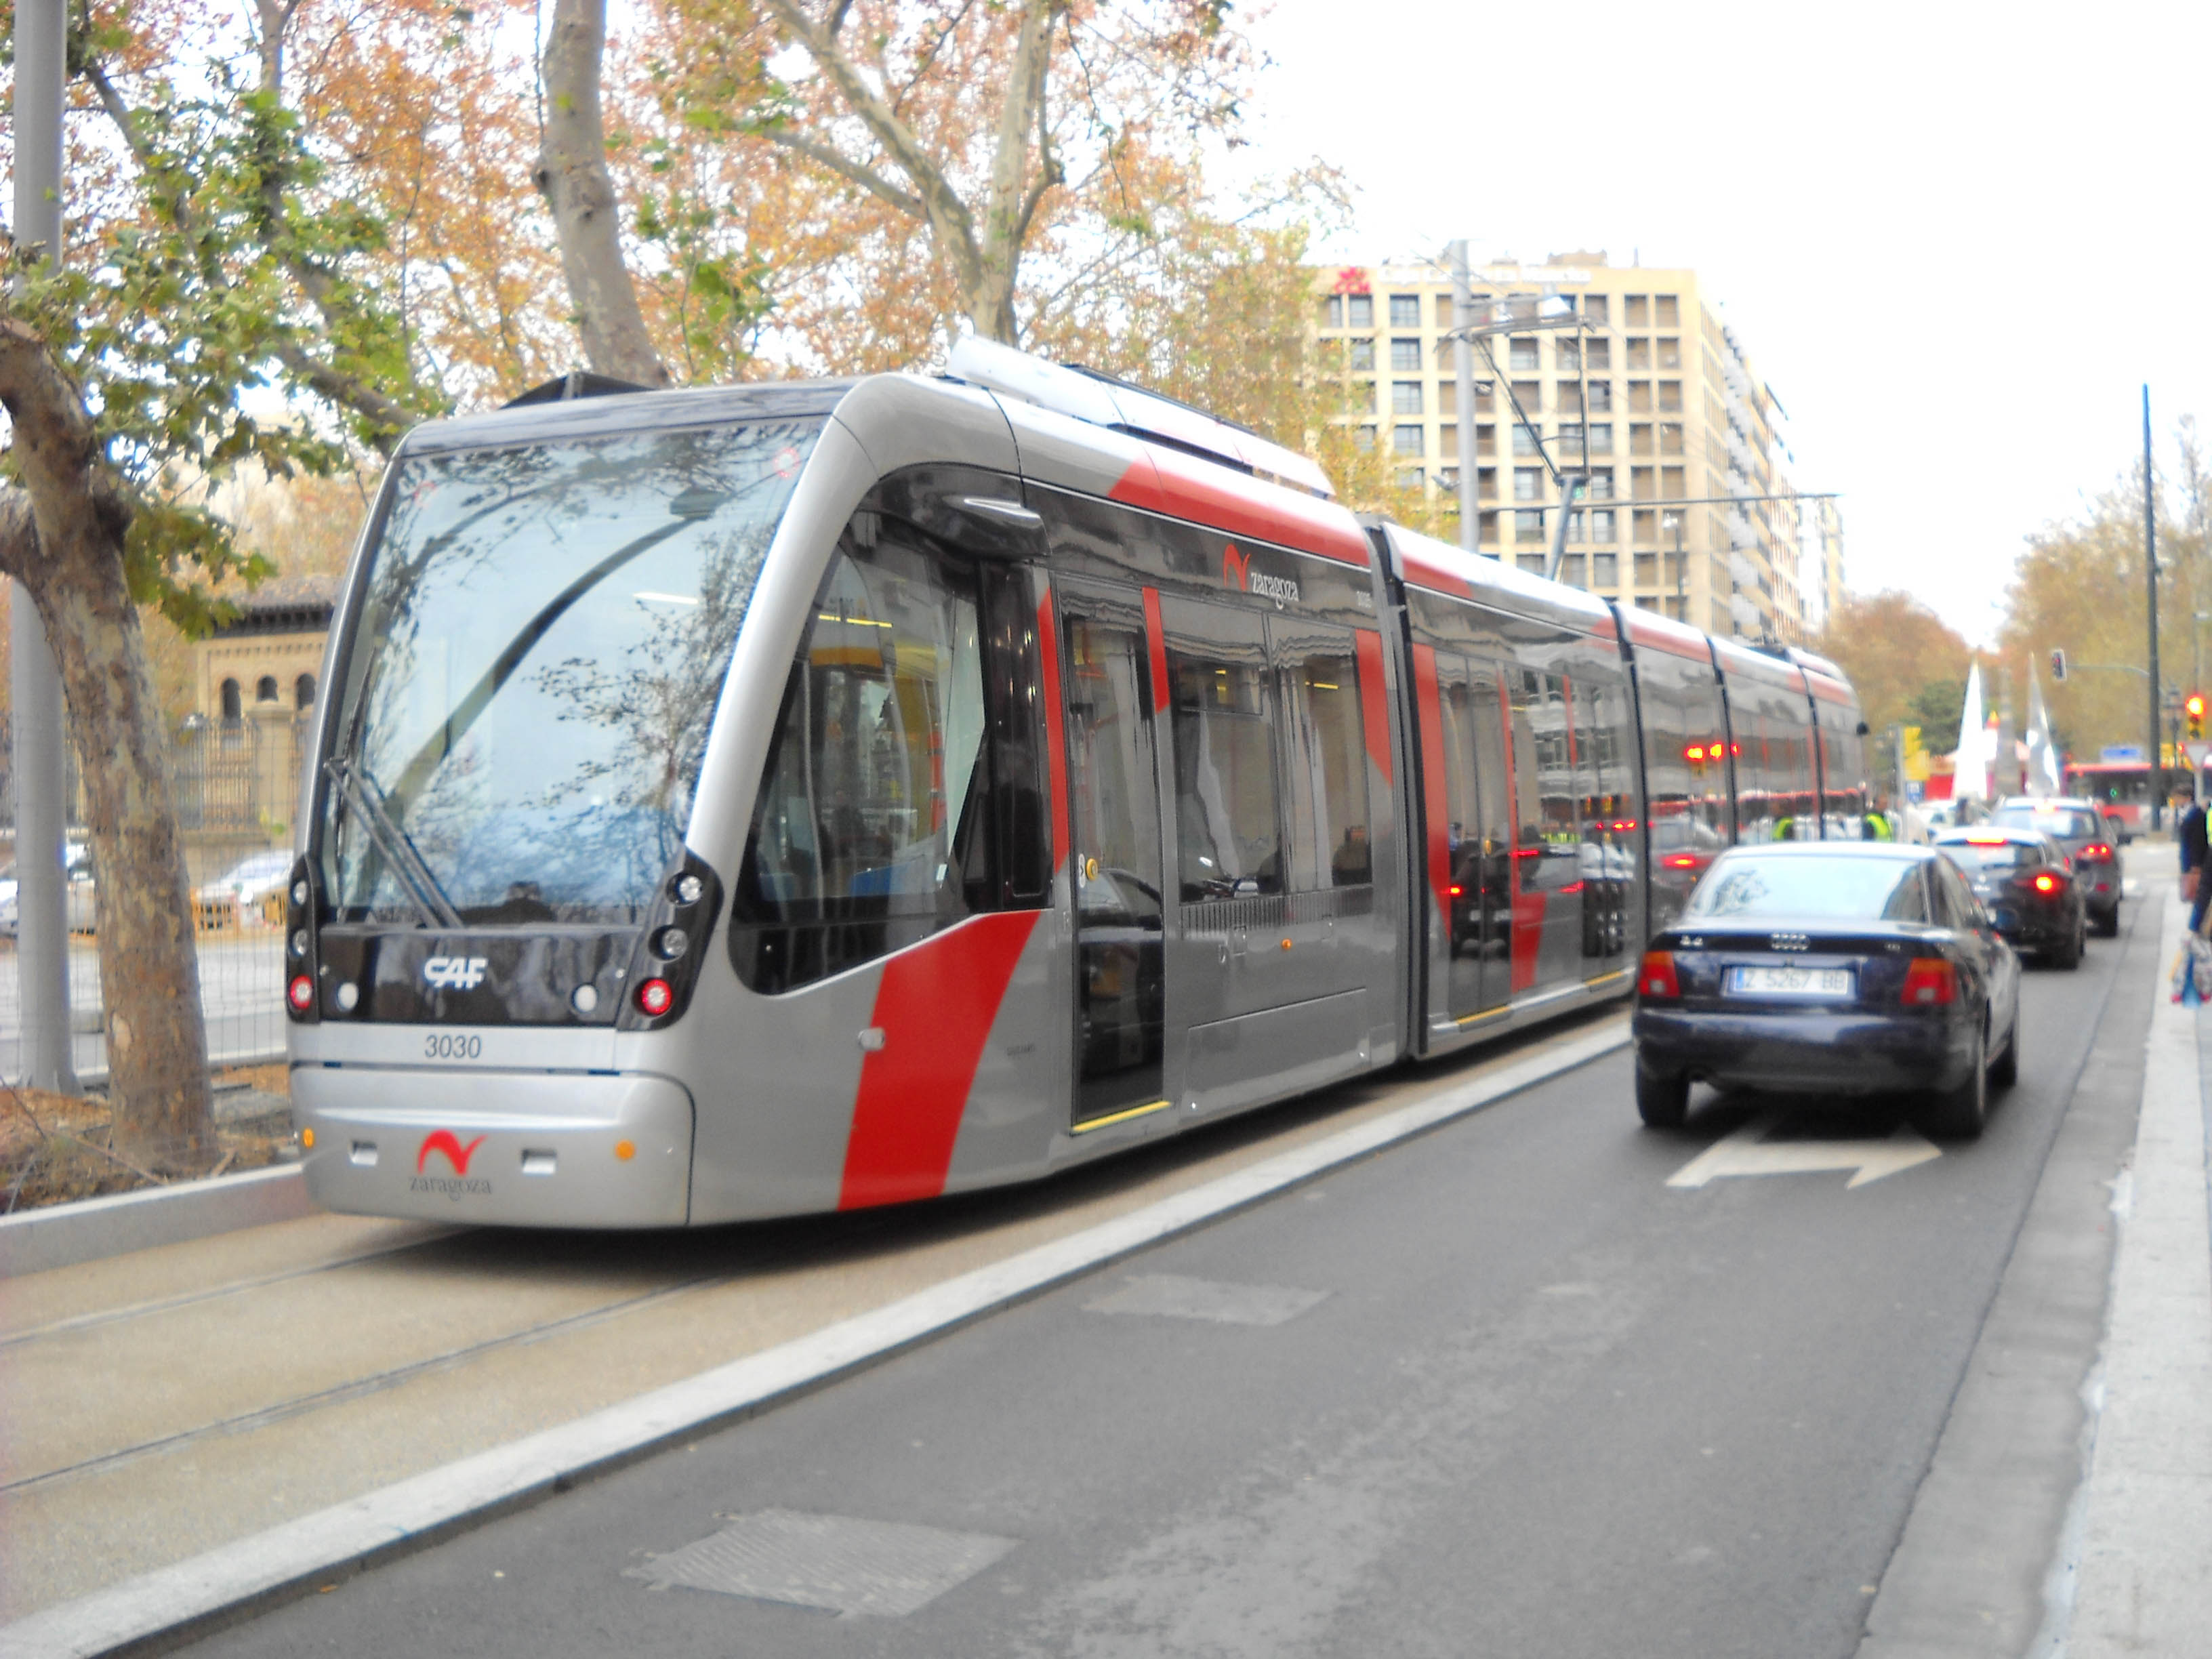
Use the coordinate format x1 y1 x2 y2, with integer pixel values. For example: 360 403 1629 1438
0 1022 1631 1659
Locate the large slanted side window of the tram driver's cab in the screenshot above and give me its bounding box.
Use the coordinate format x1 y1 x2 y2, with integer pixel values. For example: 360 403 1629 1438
730 513 996 991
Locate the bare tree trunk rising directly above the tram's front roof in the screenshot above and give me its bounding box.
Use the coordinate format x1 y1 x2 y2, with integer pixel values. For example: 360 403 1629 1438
537 0 668 385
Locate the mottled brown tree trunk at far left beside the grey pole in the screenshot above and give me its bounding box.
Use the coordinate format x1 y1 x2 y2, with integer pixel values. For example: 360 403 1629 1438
0 319 215 1172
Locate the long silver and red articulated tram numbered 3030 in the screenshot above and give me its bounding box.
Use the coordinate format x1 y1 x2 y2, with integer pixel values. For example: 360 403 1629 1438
285 341 1867 1228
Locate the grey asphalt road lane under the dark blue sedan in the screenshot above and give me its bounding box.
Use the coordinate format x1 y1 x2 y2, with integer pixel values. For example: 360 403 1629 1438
192 907 2156 1659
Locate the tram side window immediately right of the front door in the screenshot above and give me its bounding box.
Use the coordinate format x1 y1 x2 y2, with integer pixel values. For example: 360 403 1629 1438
1168 651 1283 903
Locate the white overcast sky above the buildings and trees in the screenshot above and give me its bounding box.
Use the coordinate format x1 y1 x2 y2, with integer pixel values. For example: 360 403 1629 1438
1246 0 2212 642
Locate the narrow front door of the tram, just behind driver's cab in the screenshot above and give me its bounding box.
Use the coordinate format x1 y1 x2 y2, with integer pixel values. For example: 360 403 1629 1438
1064 597 1166 1126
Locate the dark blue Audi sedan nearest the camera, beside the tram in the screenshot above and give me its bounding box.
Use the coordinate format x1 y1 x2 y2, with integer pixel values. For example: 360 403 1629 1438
1635 840 2020 1137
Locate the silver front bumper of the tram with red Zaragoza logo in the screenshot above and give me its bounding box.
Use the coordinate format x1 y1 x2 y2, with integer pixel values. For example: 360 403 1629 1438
292 1066 693 1228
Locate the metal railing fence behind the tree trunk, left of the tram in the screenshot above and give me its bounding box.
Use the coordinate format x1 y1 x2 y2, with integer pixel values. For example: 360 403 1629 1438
0 714 310 1084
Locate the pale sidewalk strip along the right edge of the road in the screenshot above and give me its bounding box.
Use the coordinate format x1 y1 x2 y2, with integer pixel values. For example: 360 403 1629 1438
2057 885 2212 1659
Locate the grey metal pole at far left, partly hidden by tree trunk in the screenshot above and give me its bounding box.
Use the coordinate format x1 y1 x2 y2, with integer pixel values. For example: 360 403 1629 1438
9 0 77 1092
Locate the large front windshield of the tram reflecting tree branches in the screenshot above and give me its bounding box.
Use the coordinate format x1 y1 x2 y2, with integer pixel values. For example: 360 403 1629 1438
323 418 823 927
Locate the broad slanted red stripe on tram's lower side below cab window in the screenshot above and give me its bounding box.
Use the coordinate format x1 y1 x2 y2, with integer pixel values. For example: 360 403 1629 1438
836 909 1044 1210
